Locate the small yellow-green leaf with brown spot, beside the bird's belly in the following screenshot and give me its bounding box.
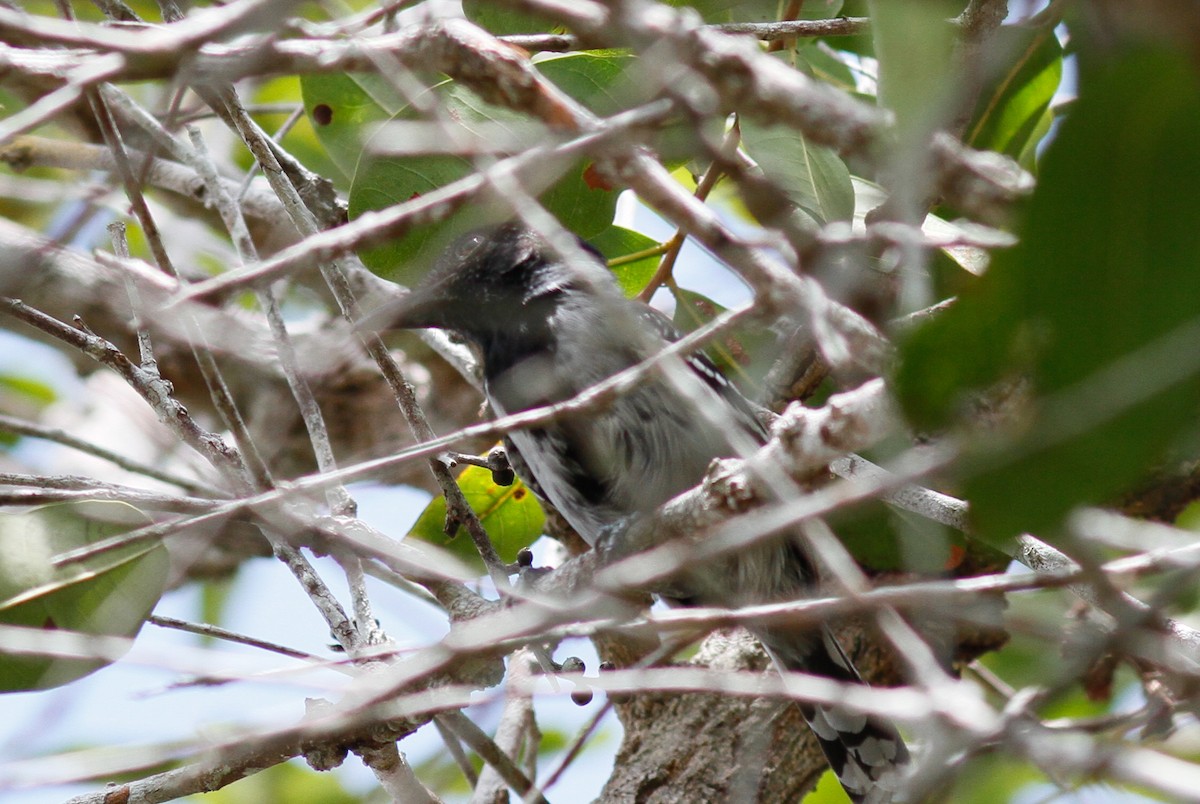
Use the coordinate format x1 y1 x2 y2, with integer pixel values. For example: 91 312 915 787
408 466 546 570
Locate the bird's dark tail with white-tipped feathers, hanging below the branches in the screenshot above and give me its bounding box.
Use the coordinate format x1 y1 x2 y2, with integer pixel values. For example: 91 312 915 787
757 629 908 804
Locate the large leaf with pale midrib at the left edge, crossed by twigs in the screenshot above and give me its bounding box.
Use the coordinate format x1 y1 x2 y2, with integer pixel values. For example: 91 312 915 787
0 500 167 691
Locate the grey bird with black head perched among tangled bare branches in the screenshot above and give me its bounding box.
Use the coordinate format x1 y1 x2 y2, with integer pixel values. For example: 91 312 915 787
385 221 908 804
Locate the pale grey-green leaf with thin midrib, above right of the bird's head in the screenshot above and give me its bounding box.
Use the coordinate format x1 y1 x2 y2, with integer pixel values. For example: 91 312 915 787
740 118 854 223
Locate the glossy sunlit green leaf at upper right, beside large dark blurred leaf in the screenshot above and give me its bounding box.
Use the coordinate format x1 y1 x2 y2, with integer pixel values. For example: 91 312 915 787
965 25 1062 158
